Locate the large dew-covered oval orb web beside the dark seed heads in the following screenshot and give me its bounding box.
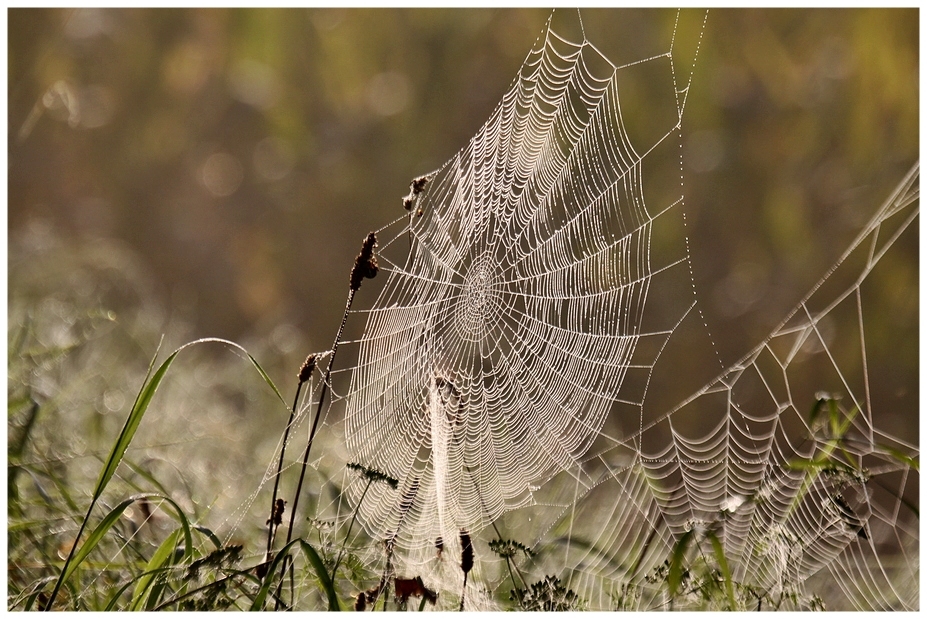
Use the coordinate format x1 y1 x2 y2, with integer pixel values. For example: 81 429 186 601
345 9 679 549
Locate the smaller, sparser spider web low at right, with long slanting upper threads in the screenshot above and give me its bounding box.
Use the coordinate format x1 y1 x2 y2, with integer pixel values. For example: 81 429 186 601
524 159 919 609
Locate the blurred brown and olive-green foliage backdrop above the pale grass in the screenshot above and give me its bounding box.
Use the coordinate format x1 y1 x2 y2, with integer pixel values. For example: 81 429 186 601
9 9 918 344
